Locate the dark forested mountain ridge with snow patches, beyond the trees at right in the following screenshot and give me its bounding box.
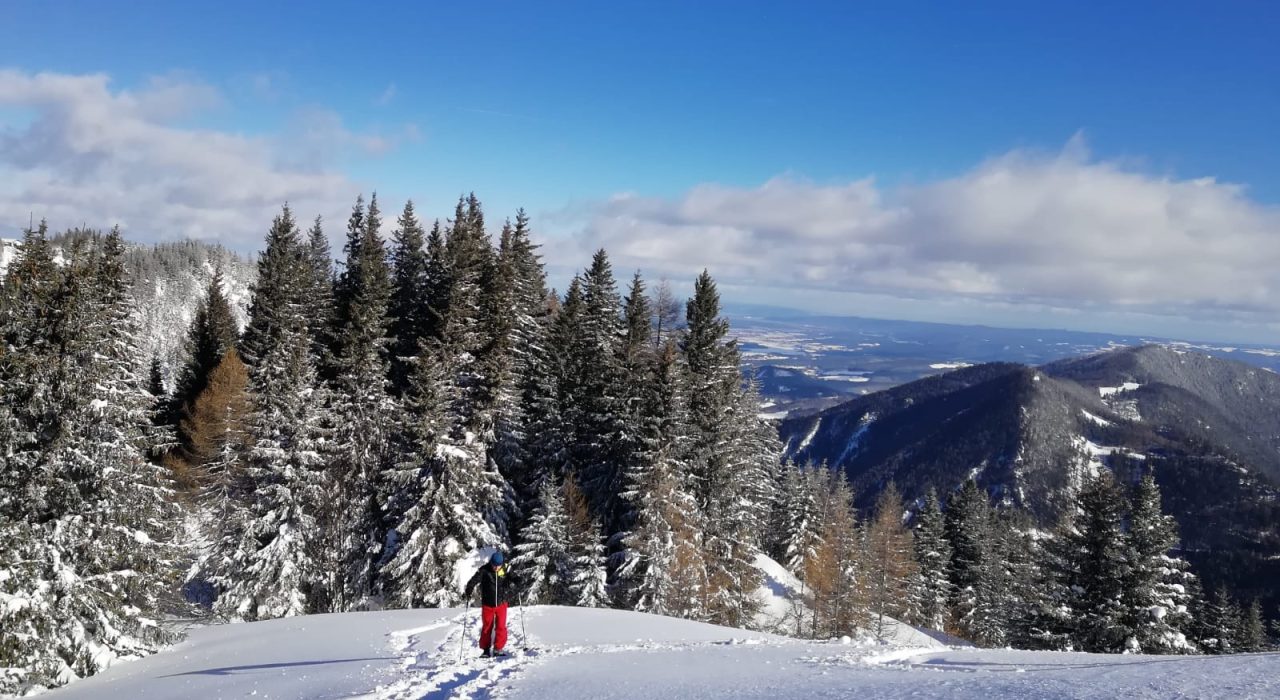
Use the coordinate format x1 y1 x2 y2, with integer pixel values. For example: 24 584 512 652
780 346 1280 603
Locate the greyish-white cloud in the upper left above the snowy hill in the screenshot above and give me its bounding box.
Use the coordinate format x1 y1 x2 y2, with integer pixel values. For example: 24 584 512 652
0 70 417 250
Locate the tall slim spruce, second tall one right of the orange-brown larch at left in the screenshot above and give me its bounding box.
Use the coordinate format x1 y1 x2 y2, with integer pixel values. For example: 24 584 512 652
315 195 399 612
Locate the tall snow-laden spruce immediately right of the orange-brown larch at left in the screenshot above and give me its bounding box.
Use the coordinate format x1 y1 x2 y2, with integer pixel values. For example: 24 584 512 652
215 206 324 619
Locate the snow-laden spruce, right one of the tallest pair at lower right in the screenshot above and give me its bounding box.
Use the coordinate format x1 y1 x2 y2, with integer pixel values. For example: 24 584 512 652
1123 473 1194 654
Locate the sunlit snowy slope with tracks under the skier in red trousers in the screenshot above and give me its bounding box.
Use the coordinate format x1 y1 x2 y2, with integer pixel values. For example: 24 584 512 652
35 607 1280 700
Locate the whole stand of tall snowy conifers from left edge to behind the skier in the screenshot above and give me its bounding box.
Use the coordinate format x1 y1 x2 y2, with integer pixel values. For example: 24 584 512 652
0 190 778 690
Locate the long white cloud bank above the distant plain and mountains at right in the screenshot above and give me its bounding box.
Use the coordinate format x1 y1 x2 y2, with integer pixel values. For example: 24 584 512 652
561 138 1280 322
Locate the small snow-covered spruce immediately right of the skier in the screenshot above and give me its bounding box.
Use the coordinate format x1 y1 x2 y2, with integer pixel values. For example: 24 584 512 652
511 479 573 605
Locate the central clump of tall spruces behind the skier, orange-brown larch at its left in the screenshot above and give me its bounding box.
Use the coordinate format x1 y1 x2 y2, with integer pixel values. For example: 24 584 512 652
172 196 778 624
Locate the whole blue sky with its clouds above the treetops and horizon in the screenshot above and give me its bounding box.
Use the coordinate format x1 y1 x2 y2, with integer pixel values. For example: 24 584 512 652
0 1 1280 339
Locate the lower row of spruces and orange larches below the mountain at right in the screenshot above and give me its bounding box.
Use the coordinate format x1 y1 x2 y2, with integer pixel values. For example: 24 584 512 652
768 463 1270 654
